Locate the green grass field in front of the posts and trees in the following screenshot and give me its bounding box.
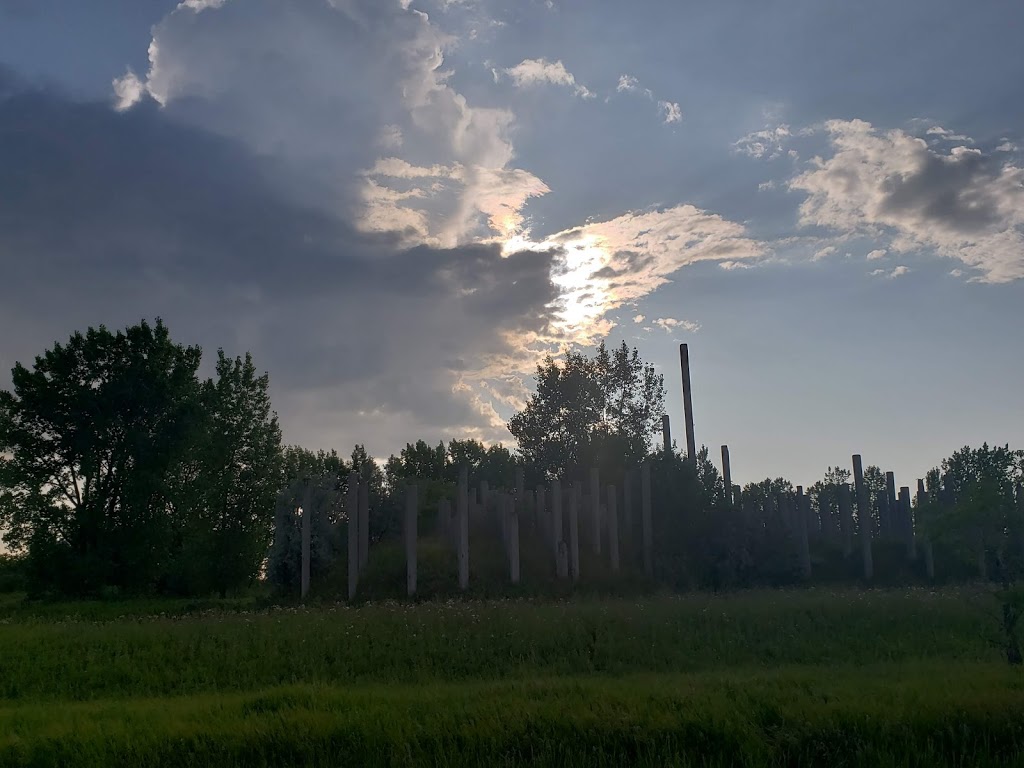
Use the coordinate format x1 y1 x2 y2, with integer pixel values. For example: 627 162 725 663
0 589 1024 767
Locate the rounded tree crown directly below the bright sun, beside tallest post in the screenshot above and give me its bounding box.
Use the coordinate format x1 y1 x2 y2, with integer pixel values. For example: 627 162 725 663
508 342 665 476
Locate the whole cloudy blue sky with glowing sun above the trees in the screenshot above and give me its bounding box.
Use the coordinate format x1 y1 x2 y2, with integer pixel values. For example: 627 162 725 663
0 0 1024 486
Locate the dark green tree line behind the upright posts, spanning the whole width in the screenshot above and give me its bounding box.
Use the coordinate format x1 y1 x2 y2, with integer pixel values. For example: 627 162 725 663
0 319 1024 595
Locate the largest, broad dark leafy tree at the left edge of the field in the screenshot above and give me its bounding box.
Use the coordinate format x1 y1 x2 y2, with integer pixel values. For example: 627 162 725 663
0 321 201 592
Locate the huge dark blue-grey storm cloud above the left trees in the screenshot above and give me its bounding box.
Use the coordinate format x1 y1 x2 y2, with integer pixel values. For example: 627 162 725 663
0 78 555 447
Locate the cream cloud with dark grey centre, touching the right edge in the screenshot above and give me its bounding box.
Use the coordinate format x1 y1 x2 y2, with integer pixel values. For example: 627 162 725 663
790 120 1024 283
